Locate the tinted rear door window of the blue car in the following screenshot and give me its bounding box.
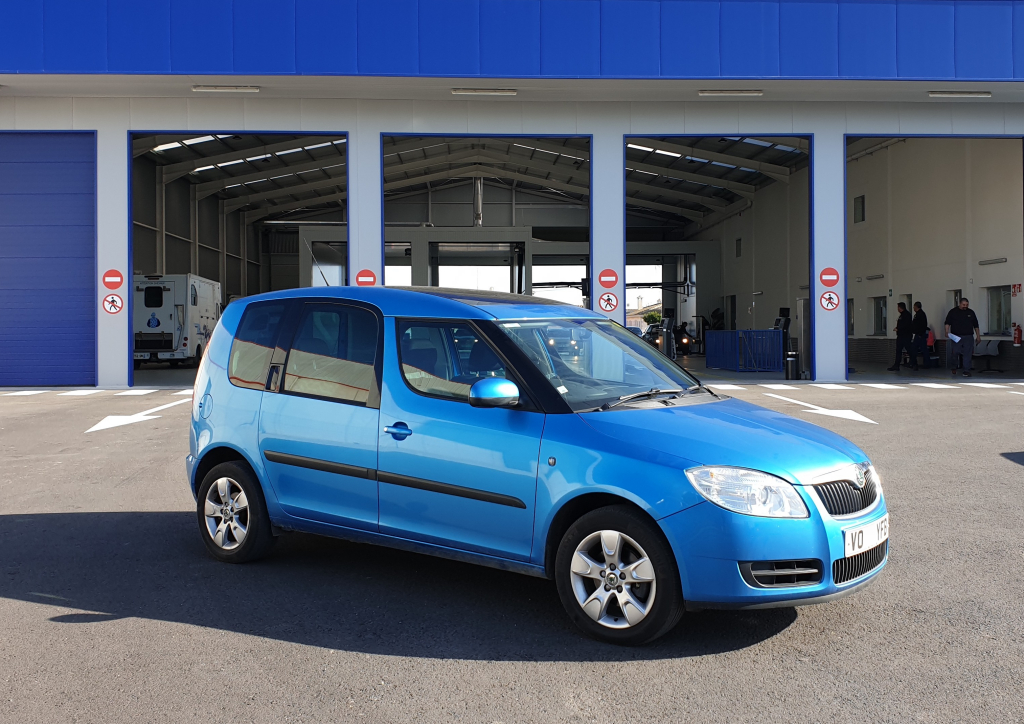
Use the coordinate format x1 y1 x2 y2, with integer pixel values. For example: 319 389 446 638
284 304 378 404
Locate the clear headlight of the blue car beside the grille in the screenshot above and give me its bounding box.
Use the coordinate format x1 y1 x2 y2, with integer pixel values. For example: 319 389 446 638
686 467 808 518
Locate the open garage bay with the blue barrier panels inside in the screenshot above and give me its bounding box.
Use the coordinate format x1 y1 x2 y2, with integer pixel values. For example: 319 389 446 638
625 136 813 380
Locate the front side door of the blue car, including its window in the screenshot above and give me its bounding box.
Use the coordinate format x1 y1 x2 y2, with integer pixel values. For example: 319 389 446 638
378 318 544 560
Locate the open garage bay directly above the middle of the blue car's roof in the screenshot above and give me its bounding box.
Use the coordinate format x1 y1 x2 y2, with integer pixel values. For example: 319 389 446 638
383 135 590 306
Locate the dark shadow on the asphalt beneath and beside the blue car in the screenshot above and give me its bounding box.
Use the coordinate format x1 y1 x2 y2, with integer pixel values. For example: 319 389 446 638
0 512 797 661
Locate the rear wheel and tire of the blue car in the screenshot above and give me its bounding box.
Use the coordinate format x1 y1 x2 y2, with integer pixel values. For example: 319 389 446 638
196 462 273 563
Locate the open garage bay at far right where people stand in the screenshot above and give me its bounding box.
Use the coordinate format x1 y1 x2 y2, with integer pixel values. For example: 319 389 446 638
846 136 1024 379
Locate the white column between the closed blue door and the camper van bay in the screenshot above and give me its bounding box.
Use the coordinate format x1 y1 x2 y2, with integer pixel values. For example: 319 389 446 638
74 98 133 387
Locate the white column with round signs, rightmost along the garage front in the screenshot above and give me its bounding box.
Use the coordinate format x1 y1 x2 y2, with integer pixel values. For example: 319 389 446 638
807 107 847 382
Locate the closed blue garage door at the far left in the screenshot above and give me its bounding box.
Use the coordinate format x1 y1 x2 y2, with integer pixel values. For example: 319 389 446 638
0 133 97 386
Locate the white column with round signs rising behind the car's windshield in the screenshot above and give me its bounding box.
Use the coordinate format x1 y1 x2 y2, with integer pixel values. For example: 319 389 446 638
579 103 629 324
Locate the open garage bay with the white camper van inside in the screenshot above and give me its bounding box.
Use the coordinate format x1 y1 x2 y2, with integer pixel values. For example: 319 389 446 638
131 132 348 385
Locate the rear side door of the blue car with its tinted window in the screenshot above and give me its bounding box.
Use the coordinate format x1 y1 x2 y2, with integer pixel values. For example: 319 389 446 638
259 302 381 530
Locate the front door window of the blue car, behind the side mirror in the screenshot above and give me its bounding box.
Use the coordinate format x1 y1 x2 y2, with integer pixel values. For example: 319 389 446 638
398 322 506 402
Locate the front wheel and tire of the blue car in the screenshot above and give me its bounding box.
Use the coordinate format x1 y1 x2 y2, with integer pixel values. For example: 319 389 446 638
555 505 683 646
